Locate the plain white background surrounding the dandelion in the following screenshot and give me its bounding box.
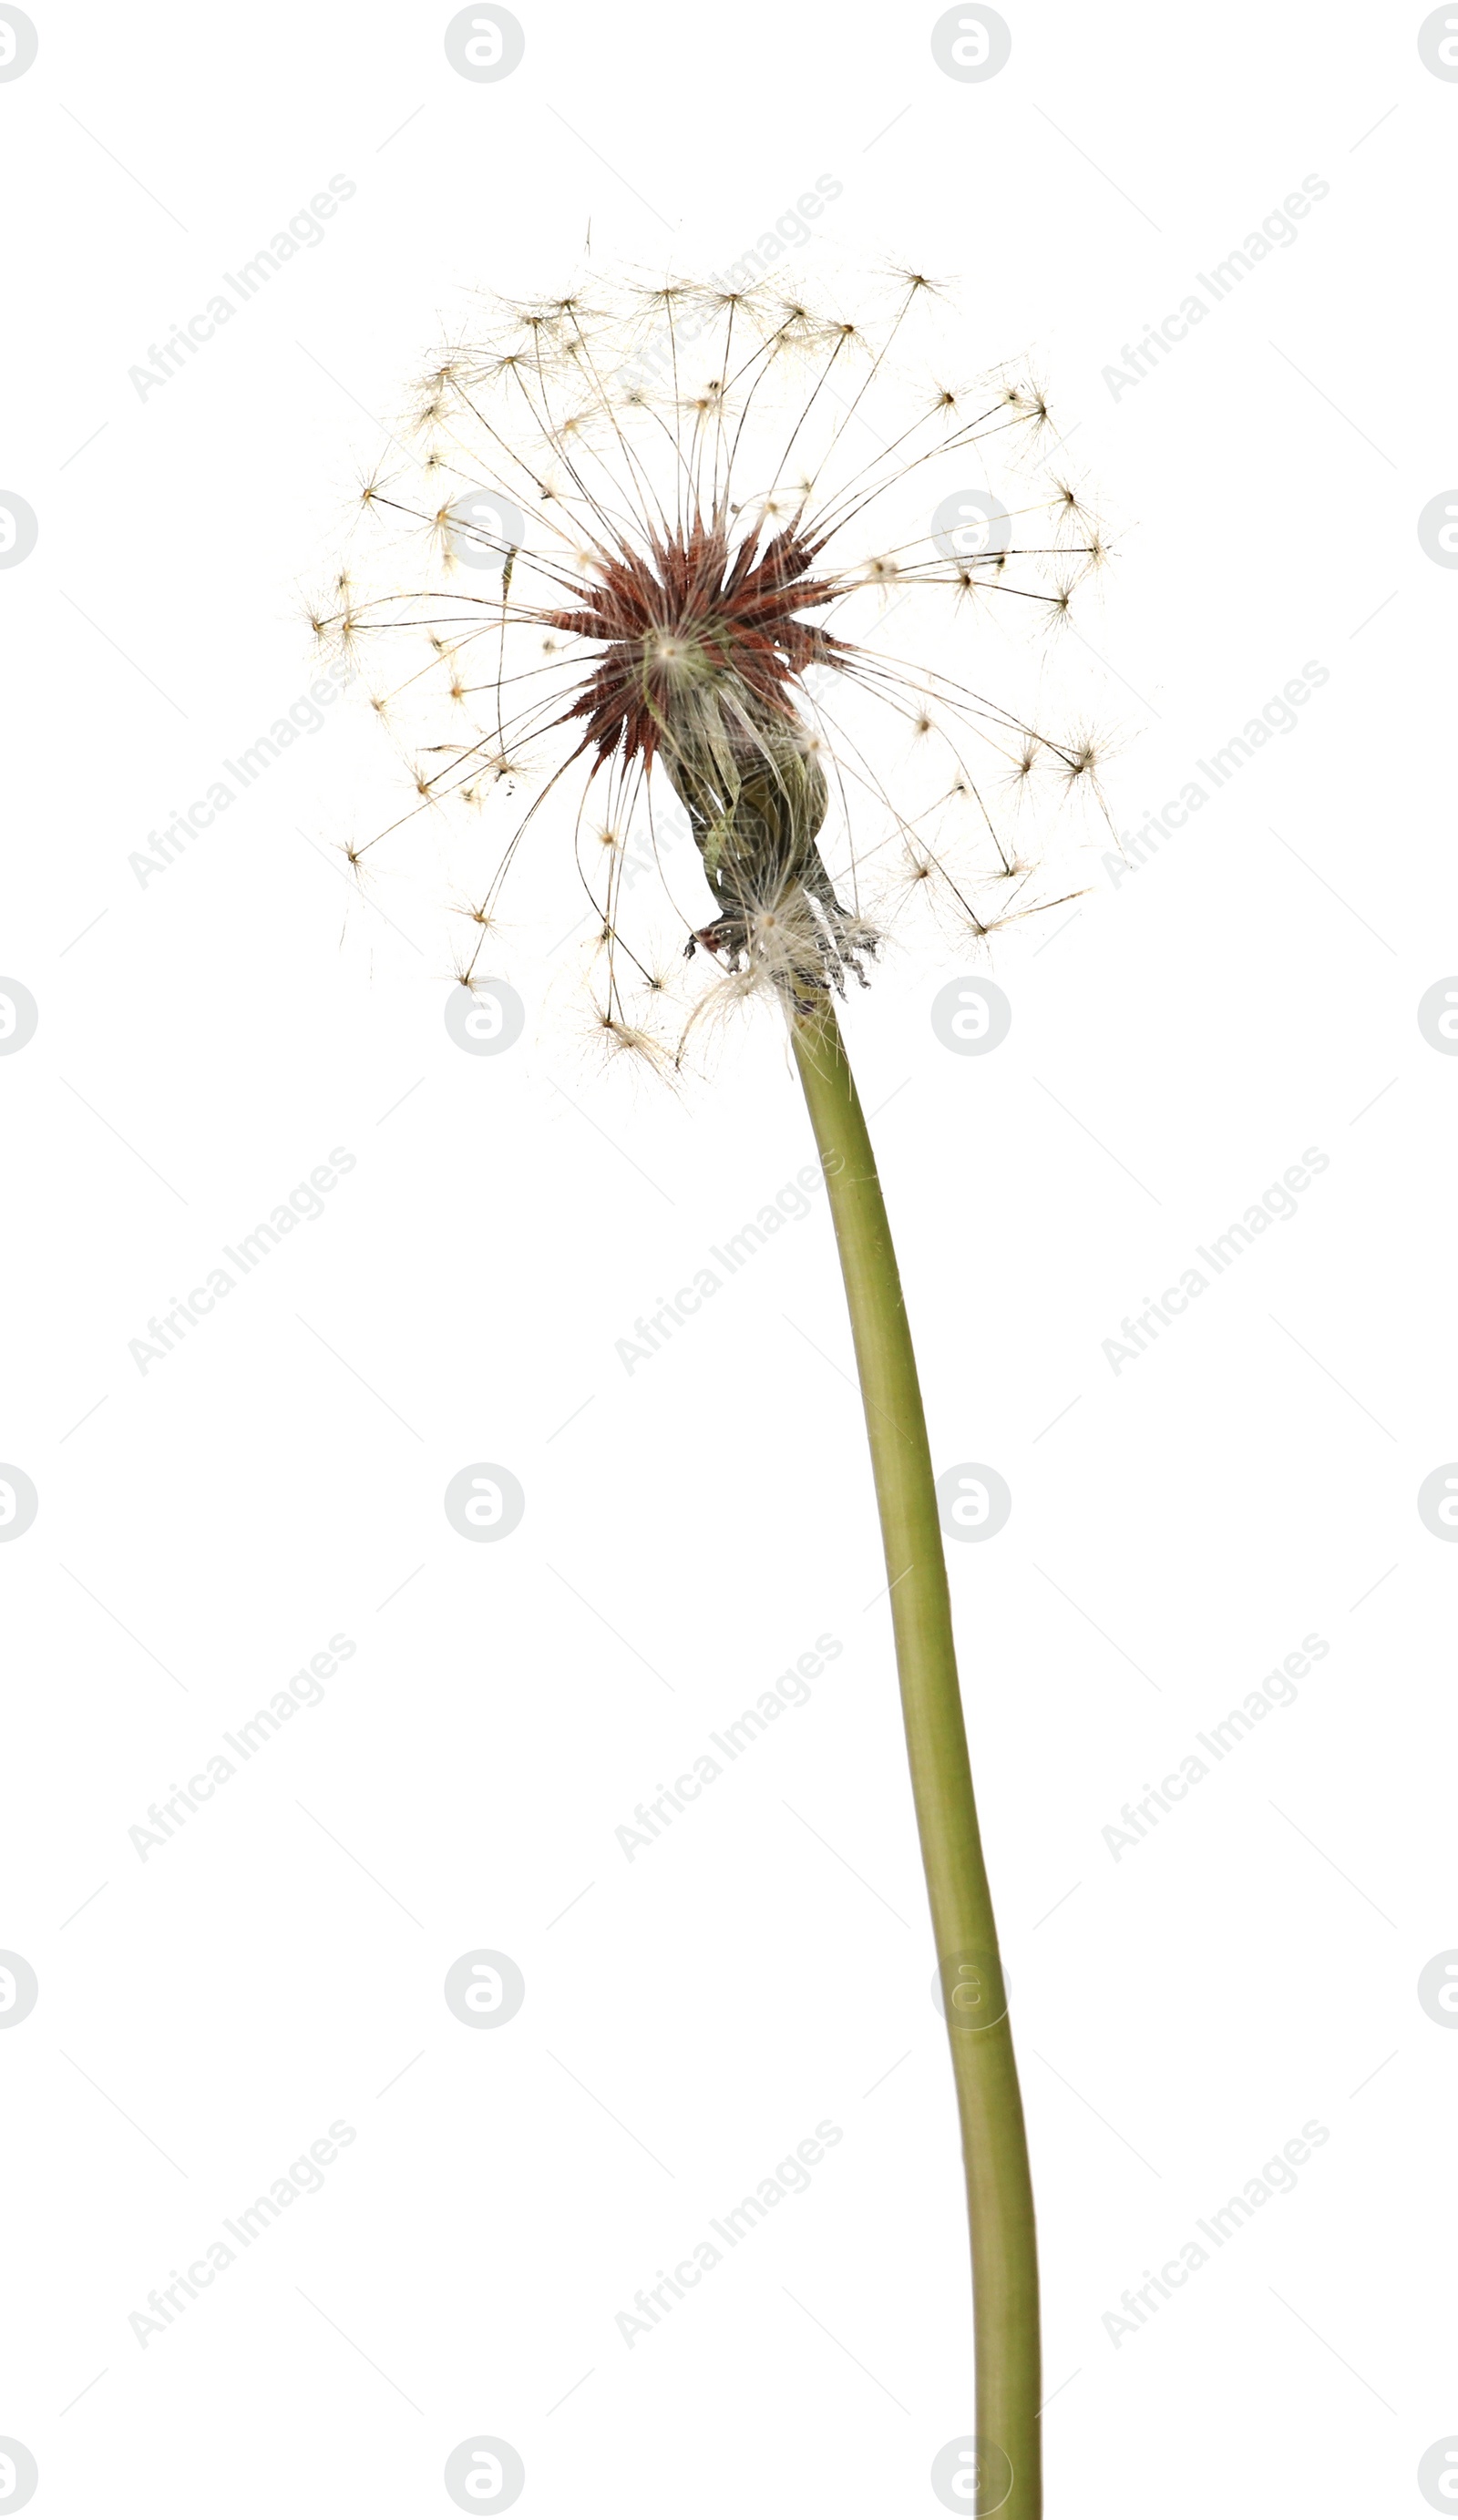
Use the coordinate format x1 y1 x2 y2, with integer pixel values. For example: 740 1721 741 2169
0 0 1458 2520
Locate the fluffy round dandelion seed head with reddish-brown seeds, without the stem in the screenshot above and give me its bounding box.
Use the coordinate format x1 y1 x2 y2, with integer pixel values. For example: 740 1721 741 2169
310 257 1107 1063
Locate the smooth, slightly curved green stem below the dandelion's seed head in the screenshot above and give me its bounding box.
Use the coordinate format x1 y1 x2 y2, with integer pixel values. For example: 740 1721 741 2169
792 998 1042 2520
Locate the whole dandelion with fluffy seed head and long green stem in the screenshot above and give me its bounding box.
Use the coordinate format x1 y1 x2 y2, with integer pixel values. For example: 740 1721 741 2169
313 272 1104 2520
